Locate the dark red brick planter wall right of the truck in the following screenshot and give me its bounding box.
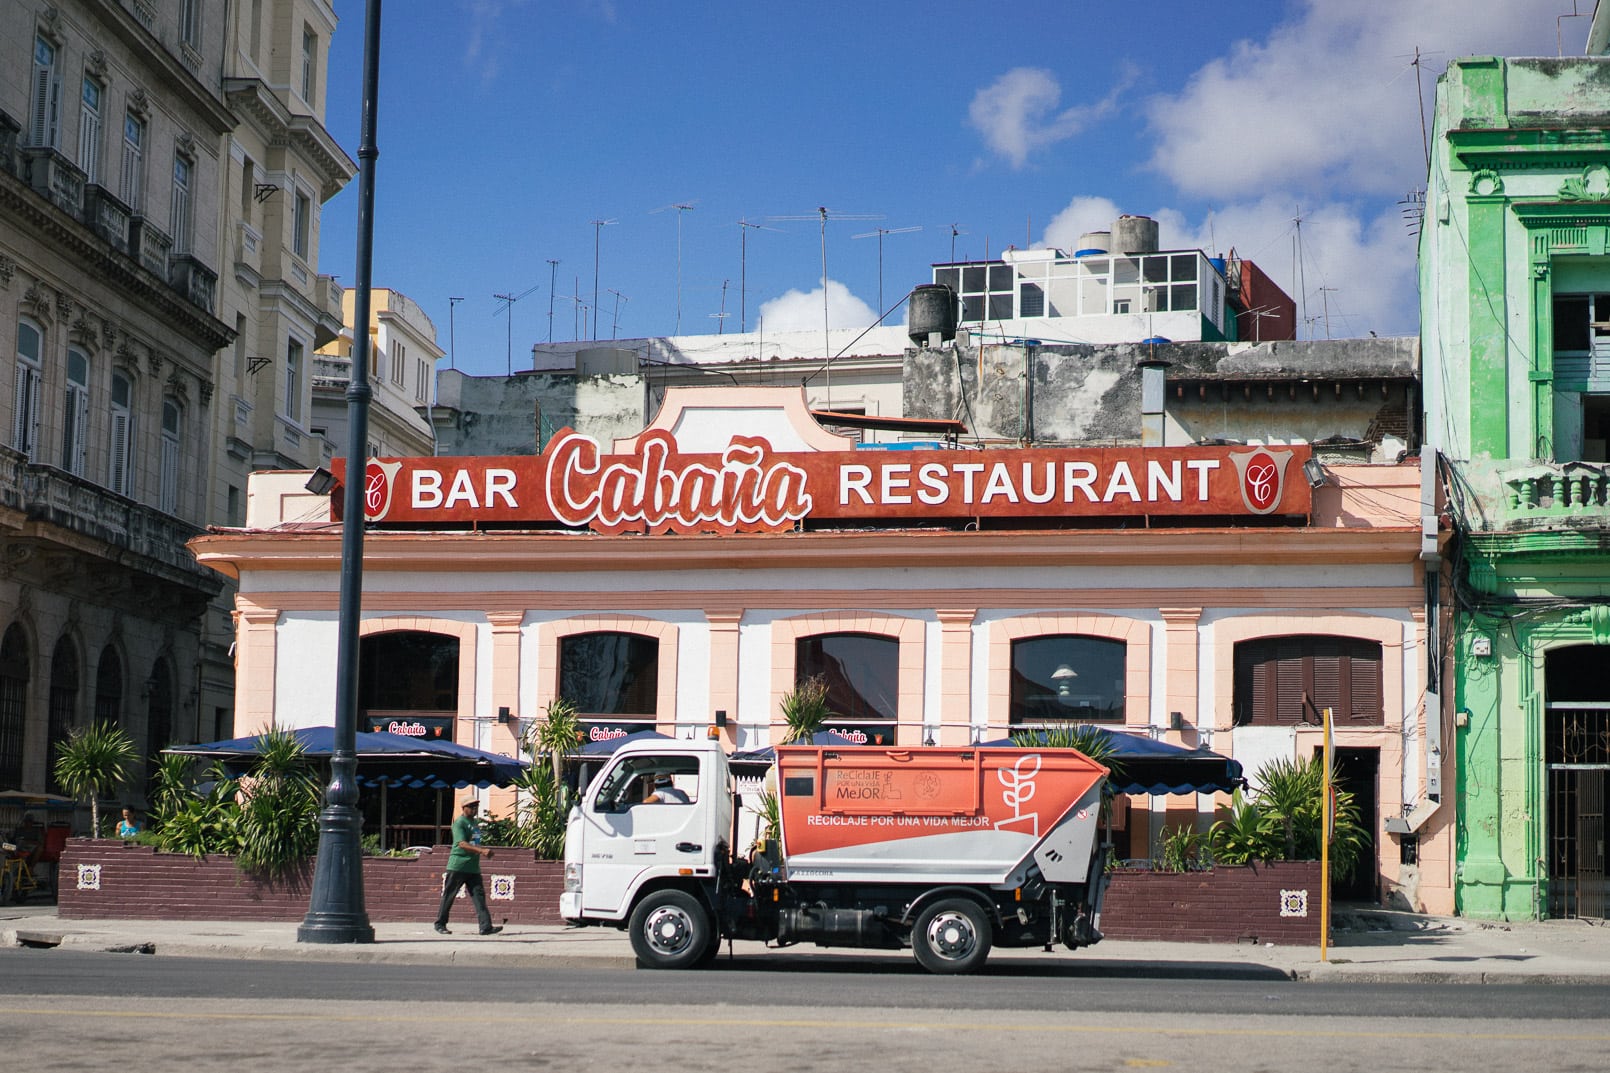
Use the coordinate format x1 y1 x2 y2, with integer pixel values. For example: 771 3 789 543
1101 860 1320 946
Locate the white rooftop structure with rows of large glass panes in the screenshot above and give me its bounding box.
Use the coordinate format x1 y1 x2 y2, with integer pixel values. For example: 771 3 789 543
934 250 1233 343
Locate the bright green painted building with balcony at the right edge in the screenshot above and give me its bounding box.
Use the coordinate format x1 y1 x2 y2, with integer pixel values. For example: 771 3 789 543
1420 41 1610 920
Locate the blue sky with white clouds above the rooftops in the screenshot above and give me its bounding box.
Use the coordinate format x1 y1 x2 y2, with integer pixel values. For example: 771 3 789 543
320 0 1592 374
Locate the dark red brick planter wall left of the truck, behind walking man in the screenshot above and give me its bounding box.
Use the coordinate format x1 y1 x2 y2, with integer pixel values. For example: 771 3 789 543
56 838 565 925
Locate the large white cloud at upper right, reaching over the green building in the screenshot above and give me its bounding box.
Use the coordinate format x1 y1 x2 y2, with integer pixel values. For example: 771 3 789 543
1146 0 1558 198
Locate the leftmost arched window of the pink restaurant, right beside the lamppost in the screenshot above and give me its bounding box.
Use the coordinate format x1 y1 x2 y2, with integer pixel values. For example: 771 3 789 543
357 630 475 744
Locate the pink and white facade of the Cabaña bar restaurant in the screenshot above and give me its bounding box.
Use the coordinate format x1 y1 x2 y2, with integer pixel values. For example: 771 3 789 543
192 388 1454 914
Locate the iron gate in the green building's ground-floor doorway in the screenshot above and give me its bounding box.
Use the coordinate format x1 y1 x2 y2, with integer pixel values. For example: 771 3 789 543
1544 702 1610 918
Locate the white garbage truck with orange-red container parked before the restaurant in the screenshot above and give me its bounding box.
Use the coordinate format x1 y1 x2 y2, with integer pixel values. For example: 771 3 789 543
560 740 1109 973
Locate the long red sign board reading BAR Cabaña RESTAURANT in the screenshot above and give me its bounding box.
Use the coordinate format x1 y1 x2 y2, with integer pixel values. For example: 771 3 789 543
333 430 1309 533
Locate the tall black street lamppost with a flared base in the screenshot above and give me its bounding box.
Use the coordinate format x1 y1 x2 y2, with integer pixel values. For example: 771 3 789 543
296 0 380 943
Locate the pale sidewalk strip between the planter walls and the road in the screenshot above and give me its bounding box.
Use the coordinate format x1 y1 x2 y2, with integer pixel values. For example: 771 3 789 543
0 905 1610 984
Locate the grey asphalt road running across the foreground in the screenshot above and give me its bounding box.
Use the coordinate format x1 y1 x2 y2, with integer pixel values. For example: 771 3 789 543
0 951 1610 1073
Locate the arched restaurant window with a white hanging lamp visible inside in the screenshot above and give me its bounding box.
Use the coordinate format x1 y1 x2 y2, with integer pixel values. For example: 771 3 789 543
1009 633 1127 727
